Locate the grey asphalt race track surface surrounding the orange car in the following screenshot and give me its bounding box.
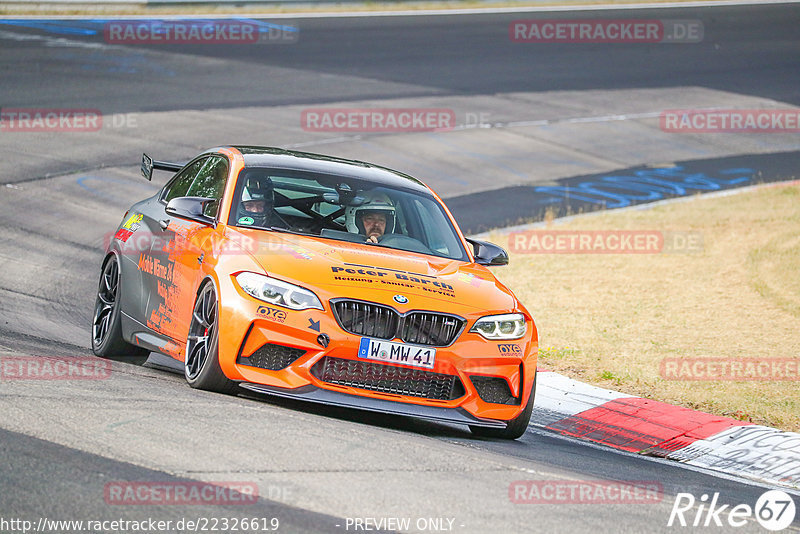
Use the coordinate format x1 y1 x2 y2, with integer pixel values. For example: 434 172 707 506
0 4 800 533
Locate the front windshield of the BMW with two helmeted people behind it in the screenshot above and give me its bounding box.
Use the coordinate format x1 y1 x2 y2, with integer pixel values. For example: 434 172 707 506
229 168 468 261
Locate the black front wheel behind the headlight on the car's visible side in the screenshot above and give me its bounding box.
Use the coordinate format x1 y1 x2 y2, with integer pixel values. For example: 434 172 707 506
184 282 239 394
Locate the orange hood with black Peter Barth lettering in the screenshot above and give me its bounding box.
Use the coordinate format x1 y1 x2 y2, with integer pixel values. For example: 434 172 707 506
231 228 518 315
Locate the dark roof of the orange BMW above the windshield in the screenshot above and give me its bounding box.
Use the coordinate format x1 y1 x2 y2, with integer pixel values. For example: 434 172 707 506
215 145 431 194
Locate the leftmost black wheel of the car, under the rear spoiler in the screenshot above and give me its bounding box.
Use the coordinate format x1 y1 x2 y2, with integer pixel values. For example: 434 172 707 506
92 254 150 364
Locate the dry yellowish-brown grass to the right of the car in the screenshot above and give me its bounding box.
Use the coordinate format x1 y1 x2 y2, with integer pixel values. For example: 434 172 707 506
490 184 800 431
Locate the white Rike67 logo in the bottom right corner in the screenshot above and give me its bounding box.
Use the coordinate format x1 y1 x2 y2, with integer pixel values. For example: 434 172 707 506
667 490 796 532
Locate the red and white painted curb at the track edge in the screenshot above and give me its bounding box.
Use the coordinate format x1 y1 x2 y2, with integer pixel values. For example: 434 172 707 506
531 369 800 489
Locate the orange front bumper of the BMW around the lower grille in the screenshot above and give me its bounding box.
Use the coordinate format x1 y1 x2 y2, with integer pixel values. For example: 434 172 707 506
219 274 538 428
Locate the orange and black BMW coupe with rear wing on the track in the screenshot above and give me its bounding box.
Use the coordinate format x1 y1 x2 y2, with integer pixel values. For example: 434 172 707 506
92 146 538 439
